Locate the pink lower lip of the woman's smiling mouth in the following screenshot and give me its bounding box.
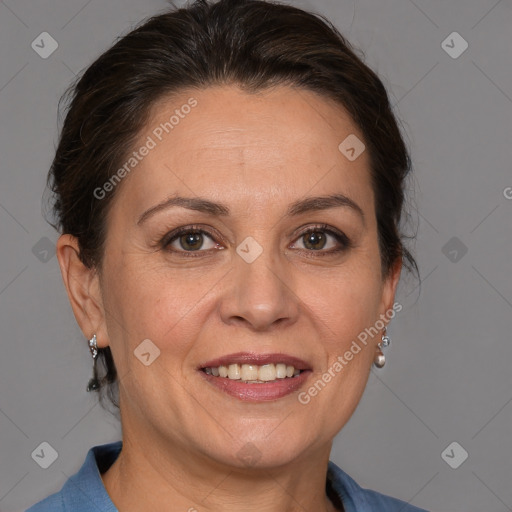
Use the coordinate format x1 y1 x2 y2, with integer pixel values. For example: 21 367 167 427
199 370 311 402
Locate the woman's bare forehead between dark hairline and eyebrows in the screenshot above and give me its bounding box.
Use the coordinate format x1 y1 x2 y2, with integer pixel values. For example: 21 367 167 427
116 85 373 216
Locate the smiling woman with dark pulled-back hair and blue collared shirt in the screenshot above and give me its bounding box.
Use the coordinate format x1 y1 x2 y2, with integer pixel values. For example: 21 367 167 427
30 0 428 512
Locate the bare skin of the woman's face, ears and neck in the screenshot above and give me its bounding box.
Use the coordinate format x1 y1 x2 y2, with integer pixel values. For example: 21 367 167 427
57 85 401 512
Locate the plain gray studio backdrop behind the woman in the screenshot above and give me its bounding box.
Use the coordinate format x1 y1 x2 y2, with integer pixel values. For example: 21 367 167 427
0 0 512 512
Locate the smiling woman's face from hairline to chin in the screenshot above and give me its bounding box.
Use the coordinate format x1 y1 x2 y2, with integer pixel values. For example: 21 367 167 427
68 86 399 467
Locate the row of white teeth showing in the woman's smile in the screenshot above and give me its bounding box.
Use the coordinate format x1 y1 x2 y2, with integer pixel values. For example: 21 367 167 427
204 363 300 384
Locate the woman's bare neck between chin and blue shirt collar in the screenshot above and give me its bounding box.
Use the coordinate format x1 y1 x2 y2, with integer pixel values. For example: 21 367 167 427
102 432 336 512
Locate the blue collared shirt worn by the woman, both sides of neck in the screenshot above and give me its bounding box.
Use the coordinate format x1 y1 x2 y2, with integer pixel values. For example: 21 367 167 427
26 441 427 512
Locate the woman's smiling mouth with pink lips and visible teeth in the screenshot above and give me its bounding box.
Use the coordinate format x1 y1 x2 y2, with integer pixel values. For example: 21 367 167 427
198 352 312 401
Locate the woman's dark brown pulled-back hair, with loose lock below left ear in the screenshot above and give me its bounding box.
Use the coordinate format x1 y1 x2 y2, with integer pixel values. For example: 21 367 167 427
48 0 419 408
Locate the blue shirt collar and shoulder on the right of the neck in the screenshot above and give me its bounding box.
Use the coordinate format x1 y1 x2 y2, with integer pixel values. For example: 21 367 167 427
327 461 427 512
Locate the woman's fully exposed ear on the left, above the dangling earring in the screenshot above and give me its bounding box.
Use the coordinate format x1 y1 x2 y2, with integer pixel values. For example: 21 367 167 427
56 234 109 348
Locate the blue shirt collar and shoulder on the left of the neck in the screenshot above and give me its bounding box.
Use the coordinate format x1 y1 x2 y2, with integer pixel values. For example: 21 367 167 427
26 441 122 512
